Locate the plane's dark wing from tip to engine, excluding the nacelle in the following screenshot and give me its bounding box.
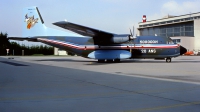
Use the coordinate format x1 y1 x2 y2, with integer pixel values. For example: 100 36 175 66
53 21 115 38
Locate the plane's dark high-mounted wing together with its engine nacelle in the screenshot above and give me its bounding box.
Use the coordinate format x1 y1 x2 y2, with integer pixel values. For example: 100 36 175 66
53 21 130 45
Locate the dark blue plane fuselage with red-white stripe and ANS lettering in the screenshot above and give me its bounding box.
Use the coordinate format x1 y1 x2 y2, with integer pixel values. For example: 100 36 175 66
37 36 186 58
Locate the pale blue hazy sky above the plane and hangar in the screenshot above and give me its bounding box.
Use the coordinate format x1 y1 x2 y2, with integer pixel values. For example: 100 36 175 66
0 0 200 44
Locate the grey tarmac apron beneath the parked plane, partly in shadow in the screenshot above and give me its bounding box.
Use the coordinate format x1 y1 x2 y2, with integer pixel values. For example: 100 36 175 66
0 56 200 112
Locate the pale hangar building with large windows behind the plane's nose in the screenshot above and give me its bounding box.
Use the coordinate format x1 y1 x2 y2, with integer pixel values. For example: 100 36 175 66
138 12 200 52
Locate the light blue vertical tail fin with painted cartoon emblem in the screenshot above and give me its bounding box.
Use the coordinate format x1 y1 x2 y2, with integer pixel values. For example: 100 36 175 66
22 6 77 37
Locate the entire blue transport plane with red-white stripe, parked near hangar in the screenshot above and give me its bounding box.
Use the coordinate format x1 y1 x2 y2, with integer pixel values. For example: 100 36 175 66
9 6 186 62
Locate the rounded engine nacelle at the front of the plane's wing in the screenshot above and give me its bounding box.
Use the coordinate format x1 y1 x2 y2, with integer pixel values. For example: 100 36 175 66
111 35 130 44
